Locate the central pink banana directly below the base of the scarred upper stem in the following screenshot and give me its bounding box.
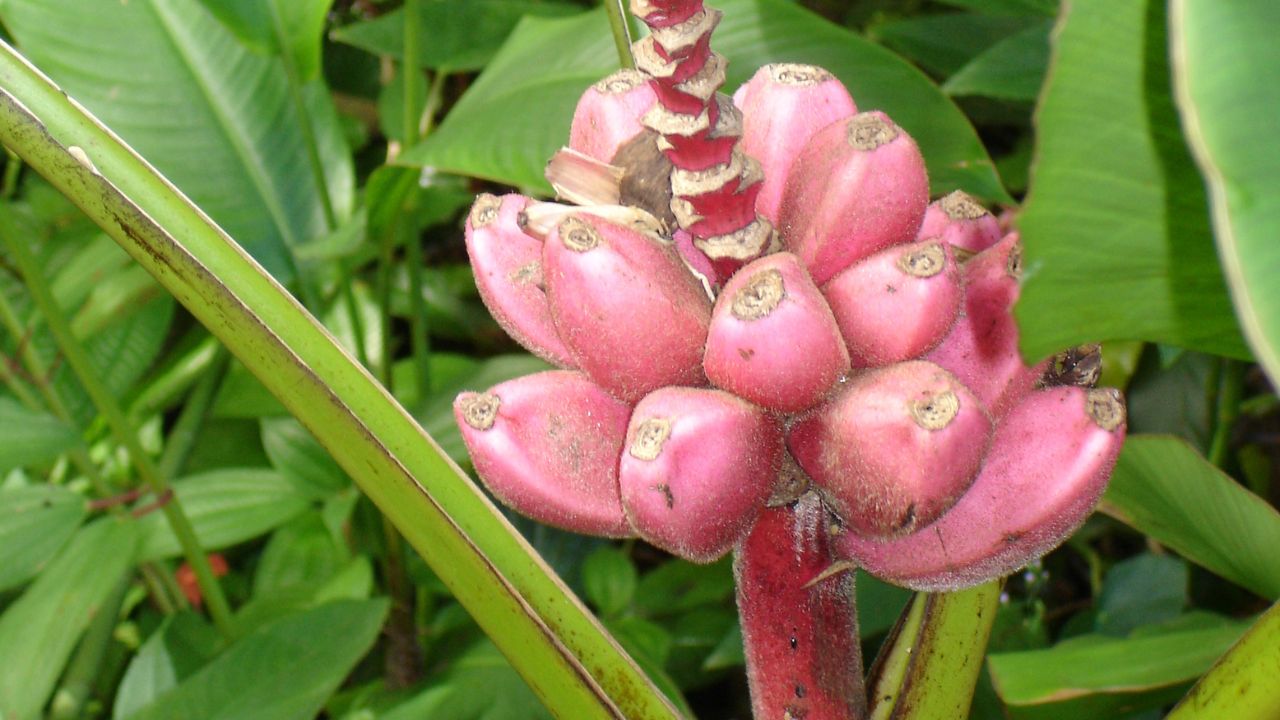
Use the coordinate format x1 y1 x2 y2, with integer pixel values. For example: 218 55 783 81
703 252 849 413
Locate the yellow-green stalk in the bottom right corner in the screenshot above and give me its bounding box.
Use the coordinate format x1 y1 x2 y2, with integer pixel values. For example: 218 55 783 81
1165 603 1280 720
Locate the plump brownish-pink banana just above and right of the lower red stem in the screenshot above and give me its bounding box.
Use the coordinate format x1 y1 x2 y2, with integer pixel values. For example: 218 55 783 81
787 360 991 537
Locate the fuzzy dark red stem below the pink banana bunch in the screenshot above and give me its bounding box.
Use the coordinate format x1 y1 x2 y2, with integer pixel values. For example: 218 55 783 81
733 493 867 720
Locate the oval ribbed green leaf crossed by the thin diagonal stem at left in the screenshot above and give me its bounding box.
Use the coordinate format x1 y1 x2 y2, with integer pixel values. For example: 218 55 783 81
138 469 308 561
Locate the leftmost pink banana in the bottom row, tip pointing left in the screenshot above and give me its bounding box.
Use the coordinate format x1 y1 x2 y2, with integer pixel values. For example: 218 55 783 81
453 370 631 537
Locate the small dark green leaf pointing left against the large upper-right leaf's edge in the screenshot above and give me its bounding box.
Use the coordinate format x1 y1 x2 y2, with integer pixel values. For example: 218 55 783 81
942 20 1053 101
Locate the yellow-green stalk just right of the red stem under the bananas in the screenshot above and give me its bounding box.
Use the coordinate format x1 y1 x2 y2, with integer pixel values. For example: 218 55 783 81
868 580 1004 720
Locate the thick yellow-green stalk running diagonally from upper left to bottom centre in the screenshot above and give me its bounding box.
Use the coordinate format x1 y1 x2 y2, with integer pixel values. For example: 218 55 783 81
0 44 678 719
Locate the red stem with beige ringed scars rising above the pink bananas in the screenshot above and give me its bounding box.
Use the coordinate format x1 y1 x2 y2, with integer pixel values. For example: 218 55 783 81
631 0 773 269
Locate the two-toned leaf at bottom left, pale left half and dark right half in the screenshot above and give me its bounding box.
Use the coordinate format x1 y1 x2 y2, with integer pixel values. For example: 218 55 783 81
111 610 219 717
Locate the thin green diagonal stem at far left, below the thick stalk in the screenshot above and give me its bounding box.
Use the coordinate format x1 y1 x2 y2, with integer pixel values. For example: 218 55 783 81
0 213 234 638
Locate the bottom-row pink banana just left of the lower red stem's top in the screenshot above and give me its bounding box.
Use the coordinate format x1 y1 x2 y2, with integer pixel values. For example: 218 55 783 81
618 387 782 562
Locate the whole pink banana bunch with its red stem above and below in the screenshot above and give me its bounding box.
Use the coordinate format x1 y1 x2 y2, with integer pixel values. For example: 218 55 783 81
454 0 1125 717
